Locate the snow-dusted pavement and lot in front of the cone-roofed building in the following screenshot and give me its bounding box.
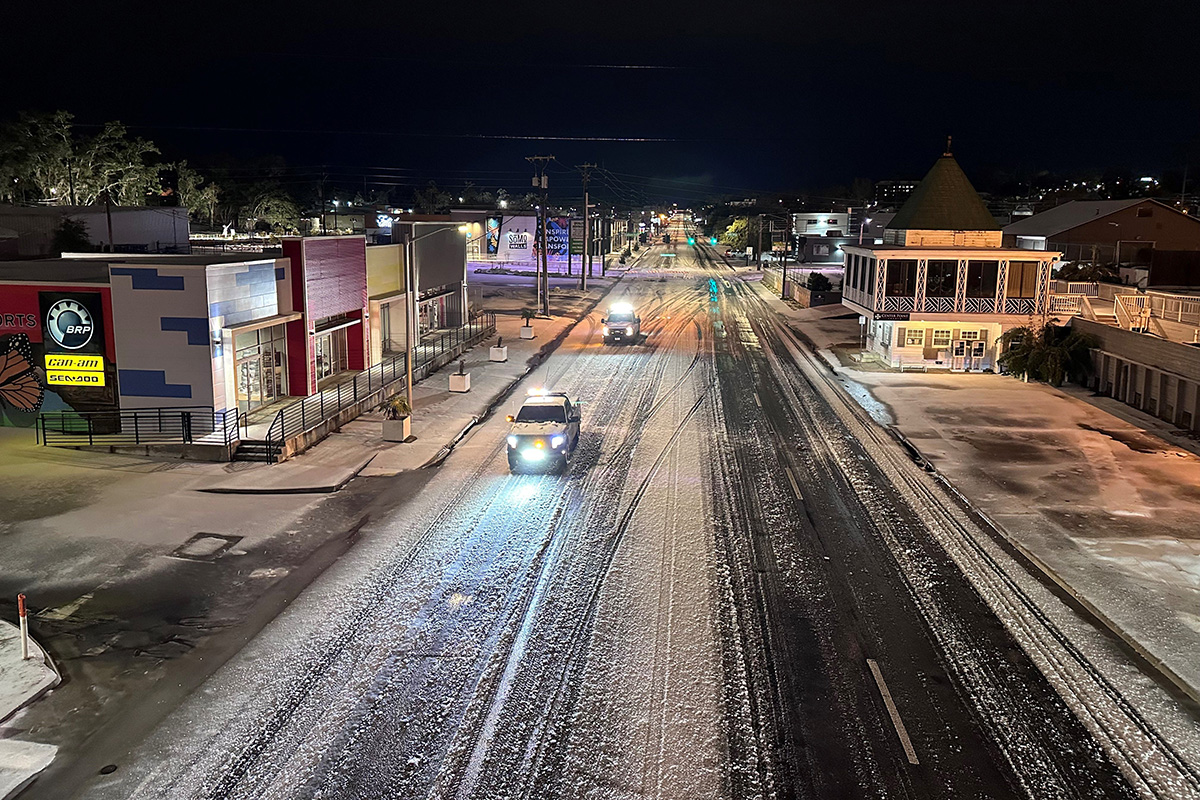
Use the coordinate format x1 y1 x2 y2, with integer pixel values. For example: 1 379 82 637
744 275 1200 700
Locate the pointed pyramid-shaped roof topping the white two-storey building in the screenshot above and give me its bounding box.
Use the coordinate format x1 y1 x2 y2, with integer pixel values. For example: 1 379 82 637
888 154 1000 230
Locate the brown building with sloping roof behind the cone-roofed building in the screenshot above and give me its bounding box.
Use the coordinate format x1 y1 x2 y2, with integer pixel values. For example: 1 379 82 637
1003 198 1200 266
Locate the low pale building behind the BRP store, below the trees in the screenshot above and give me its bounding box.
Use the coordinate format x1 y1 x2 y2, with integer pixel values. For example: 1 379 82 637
0 205 190 260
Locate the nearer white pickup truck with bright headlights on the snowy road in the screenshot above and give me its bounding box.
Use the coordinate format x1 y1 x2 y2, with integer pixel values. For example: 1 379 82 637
508 390 580 473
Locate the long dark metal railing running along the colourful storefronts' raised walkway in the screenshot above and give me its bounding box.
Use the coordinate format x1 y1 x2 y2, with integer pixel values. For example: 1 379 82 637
265 312 496 463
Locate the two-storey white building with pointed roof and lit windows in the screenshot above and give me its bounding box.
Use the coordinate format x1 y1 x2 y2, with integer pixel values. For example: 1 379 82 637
842 152 1060 372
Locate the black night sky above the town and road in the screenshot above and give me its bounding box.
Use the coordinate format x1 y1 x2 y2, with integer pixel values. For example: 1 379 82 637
9 0 1200 201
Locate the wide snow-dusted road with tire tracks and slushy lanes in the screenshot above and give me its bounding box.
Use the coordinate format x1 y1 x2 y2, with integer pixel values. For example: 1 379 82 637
84 247 1194 800
